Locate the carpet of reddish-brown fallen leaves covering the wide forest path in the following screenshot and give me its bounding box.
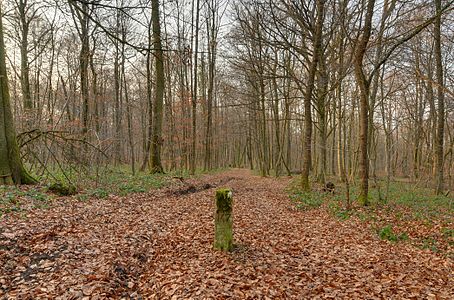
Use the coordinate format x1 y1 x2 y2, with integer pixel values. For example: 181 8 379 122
0 170 454 299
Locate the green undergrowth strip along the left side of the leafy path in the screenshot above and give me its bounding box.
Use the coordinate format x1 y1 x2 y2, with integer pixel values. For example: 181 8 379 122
0 166 227 218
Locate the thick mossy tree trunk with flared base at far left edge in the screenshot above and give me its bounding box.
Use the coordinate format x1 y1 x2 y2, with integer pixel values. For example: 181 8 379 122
0 8 35 184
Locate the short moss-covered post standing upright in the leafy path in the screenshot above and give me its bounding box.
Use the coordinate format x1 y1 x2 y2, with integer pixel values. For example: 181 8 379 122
214 189 233 251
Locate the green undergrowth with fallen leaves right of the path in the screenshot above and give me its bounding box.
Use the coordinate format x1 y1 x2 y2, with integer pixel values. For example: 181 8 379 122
287 176 454 258
